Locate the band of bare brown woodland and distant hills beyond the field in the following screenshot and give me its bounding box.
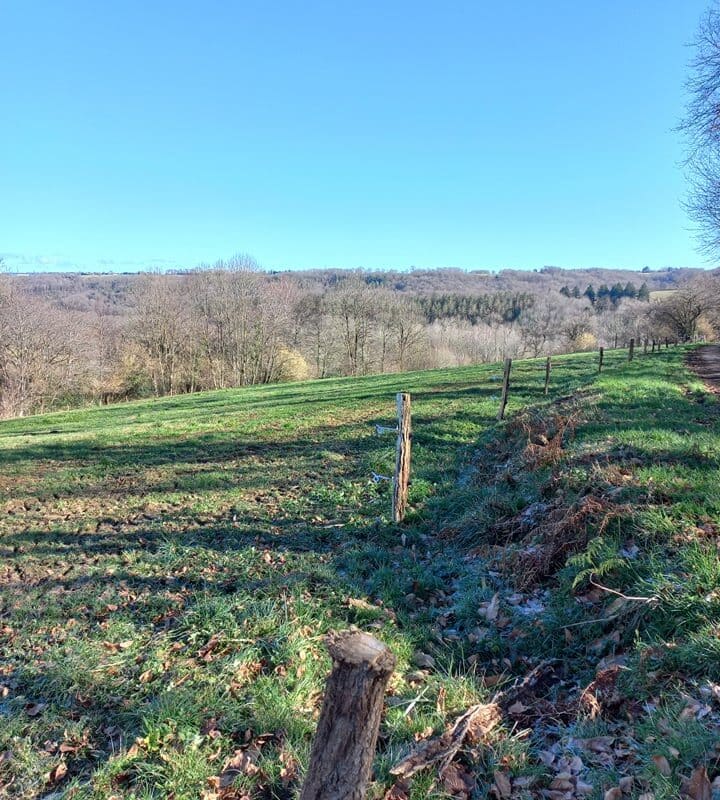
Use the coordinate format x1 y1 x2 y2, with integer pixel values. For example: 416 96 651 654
0 264 720 416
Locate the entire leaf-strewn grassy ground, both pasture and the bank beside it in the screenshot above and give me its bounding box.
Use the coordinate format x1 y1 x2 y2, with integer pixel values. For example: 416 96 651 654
0 348 720 800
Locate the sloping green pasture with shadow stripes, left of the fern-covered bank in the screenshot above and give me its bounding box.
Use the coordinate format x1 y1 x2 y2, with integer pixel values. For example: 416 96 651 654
0 351 702 800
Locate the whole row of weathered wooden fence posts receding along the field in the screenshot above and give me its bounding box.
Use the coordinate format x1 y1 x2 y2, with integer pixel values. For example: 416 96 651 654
300 339 677 800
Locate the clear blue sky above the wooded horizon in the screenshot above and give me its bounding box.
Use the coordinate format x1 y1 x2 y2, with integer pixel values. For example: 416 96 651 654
0 0 708 269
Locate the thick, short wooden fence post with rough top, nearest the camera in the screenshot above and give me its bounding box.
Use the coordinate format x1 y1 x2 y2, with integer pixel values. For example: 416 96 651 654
300 631 395 800
